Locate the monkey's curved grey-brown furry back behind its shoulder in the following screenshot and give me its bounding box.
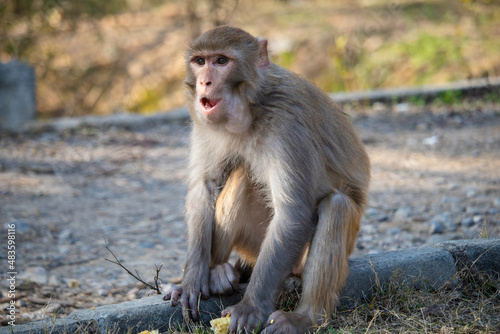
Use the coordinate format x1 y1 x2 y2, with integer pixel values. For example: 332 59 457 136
264 64 370 204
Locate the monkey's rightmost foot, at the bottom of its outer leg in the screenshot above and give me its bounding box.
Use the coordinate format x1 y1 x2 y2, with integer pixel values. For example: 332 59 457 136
264 311 312 334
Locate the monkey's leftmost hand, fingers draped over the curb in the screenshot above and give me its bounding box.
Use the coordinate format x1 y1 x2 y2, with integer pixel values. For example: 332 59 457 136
163 268 210 320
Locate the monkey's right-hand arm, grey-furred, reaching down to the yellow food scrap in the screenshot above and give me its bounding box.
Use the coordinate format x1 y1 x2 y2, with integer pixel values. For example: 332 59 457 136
222 132 319 331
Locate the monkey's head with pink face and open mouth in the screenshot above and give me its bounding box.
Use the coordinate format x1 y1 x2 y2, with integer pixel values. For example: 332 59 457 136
184 26 270 133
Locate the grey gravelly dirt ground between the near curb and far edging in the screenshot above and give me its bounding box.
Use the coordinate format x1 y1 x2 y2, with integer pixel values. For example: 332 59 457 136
0 104 500 325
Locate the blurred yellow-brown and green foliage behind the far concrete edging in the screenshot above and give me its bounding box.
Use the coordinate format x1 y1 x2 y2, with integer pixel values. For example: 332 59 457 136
0 0 500 117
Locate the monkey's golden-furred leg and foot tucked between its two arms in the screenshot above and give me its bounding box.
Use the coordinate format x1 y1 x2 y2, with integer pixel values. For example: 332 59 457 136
210 167 269 294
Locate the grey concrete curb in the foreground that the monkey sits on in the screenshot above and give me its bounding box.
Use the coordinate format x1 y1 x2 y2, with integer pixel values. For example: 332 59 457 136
0 238 500 334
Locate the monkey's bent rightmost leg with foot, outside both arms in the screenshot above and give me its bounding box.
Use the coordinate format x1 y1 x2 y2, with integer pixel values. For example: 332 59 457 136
266 192 363 333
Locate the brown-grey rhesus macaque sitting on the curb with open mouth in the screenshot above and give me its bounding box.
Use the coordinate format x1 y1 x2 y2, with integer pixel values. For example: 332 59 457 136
164 26 370 333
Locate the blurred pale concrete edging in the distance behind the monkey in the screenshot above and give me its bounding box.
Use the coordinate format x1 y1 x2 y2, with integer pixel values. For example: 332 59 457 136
8 77 500 133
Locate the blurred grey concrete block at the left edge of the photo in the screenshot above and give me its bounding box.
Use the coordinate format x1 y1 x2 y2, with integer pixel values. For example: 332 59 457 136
0 60 36 131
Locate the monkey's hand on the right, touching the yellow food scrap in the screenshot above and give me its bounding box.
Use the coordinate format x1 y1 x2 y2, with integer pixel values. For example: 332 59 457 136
222 297 274 333
